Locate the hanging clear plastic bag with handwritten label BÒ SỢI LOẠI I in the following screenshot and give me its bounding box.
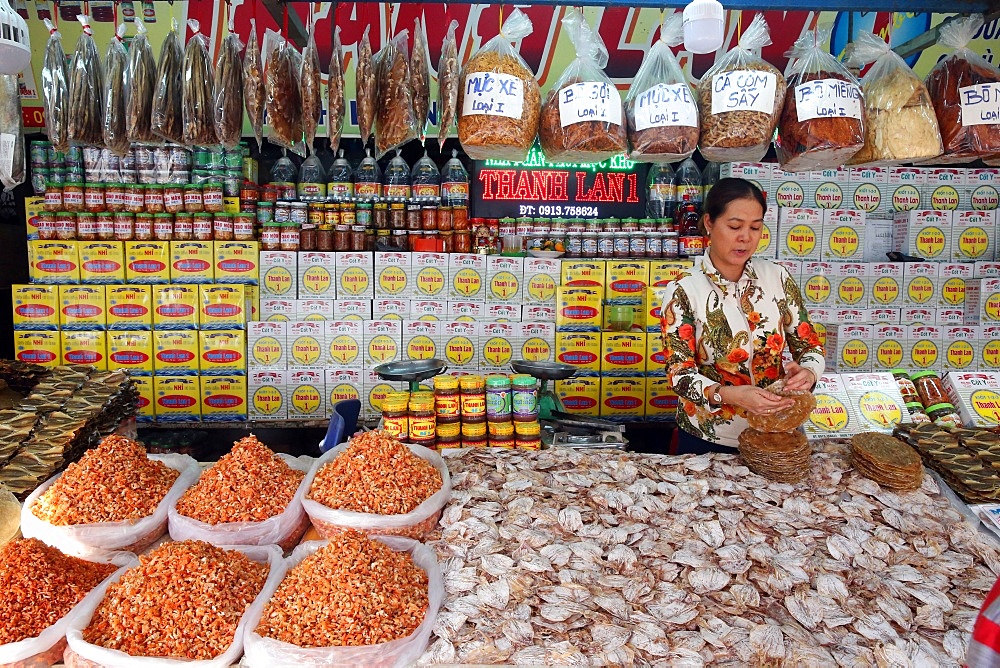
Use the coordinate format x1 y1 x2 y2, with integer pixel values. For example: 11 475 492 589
538 9 628 162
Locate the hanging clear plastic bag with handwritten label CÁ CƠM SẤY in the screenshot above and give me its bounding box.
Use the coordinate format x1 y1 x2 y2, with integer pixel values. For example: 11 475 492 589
697 14 785 162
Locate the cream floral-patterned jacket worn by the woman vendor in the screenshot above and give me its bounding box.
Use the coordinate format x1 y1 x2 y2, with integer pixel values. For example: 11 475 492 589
660 255 825 447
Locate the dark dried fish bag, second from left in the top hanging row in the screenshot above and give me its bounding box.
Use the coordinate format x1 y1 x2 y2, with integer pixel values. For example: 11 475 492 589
69 14 104 148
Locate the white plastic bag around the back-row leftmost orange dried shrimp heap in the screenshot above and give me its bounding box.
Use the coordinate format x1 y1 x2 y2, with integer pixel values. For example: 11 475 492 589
21 454 200 559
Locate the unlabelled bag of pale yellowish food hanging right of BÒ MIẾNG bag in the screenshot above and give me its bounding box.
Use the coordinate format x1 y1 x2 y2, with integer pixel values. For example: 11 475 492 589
845 32 943 165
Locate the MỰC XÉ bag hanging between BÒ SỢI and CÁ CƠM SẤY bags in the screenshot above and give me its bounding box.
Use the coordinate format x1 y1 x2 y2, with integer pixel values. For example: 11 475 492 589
625 13 698 163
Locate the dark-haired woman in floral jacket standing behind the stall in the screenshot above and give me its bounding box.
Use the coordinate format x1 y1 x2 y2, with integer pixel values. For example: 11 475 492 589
661 179 824 453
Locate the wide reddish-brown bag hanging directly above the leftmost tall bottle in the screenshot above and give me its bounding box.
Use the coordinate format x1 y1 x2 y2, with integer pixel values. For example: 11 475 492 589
264 30 306 156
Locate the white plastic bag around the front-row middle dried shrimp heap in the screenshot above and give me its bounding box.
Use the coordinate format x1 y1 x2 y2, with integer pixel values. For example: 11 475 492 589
65 545 288 668
